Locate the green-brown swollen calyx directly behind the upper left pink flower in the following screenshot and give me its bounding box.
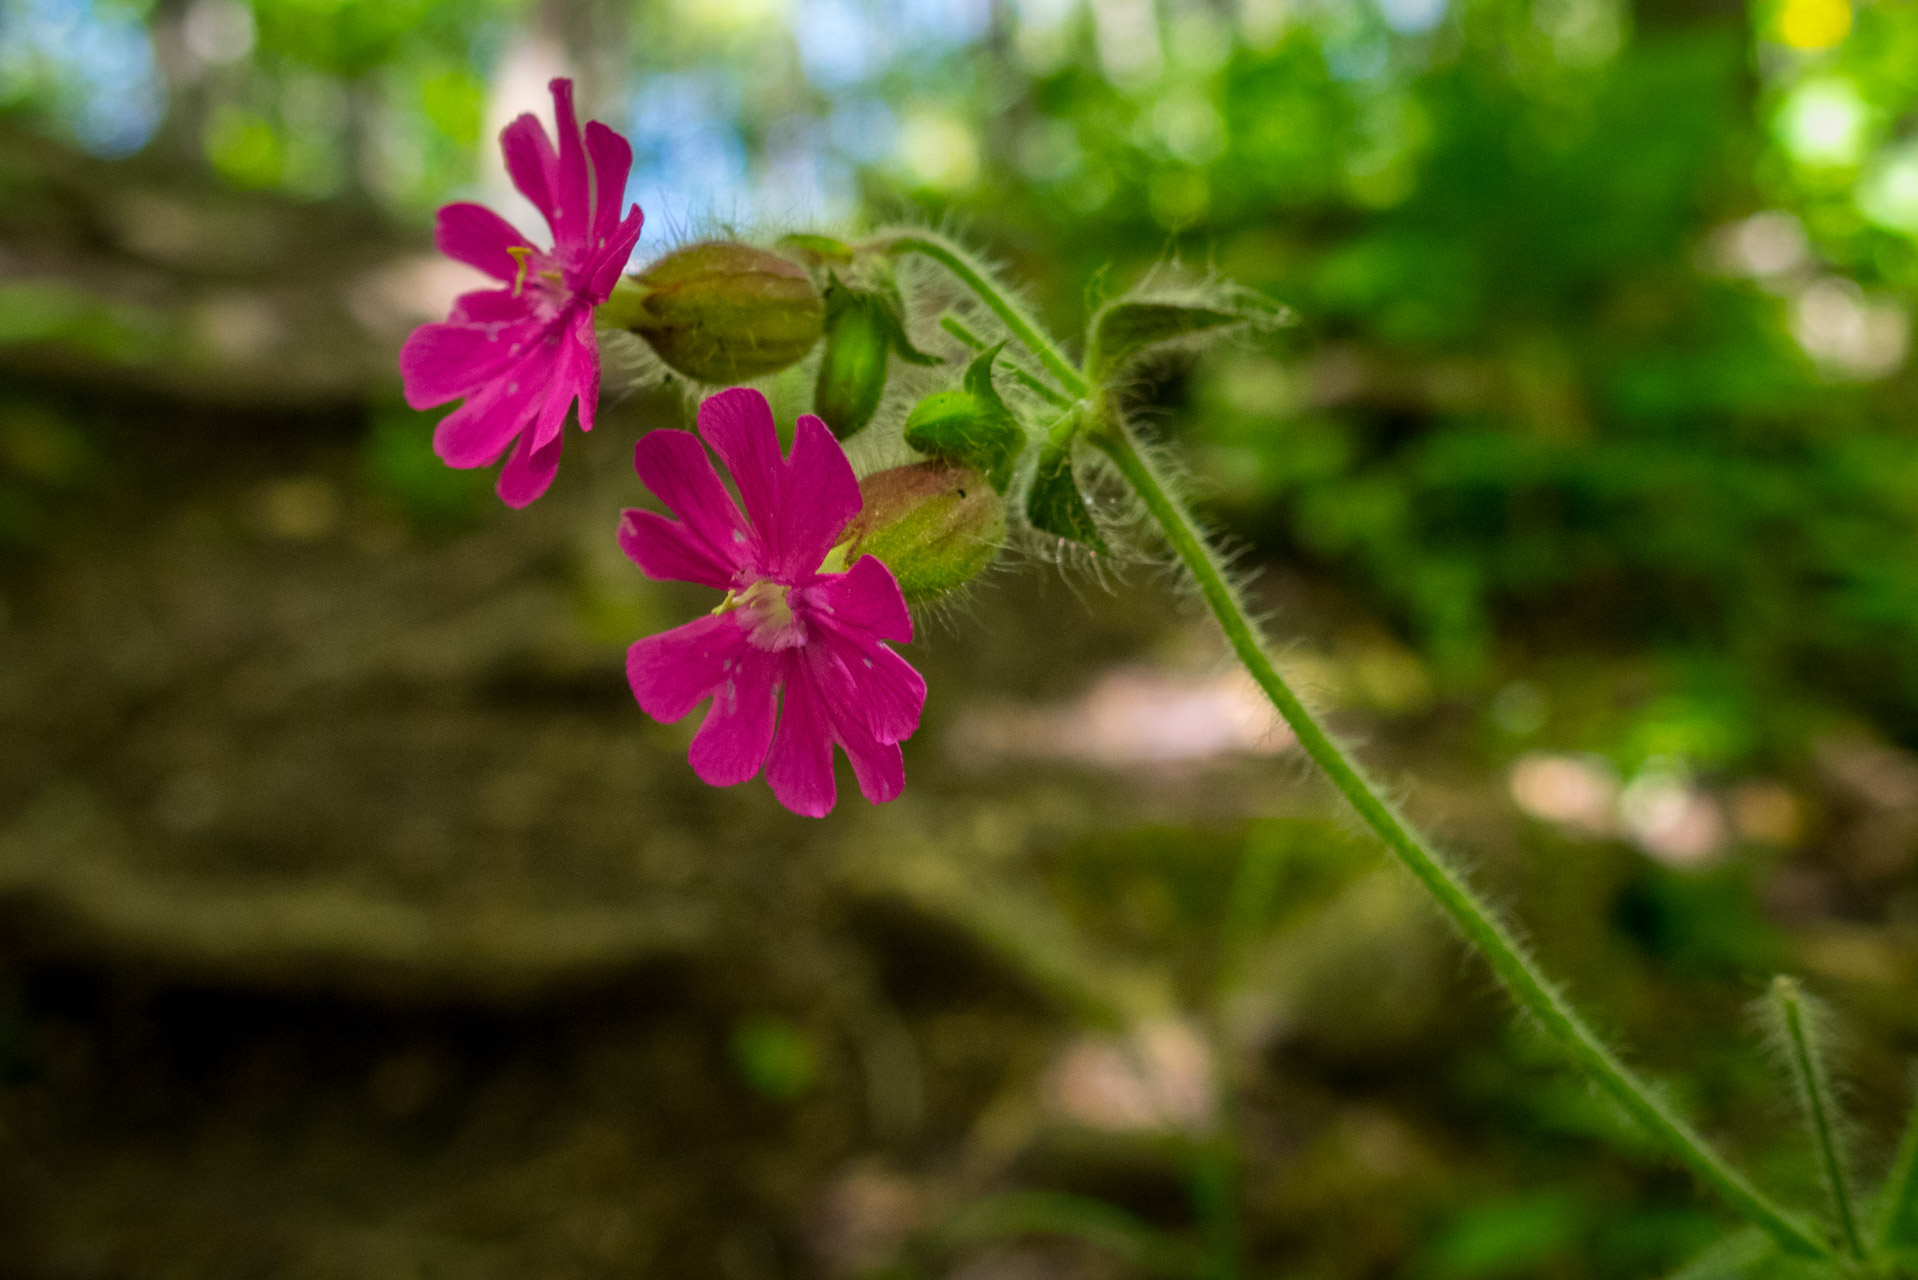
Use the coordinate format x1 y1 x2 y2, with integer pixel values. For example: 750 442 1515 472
600 240 825 386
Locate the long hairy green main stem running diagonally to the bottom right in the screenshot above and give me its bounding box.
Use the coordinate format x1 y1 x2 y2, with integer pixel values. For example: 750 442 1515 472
1089 420 1832 1259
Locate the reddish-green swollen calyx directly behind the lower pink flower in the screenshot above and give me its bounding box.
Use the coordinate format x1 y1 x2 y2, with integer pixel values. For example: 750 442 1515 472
844 462 1005 604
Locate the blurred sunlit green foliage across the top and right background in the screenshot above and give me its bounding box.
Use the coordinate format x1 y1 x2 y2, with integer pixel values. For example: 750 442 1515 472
11 0 1918 768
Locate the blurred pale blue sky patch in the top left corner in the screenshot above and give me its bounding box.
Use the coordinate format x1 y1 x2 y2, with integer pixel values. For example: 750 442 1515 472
0 0 167 155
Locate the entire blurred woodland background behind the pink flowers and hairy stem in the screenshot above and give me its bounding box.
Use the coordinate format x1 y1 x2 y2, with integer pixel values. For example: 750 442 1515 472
0 0 1918 1280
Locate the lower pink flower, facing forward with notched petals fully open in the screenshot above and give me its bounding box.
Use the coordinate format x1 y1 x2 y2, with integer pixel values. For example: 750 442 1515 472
620 388 926 818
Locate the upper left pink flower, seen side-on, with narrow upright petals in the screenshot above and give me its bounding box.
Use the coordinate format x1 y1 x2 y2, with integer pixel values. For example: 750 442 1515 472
399 81 643 507
